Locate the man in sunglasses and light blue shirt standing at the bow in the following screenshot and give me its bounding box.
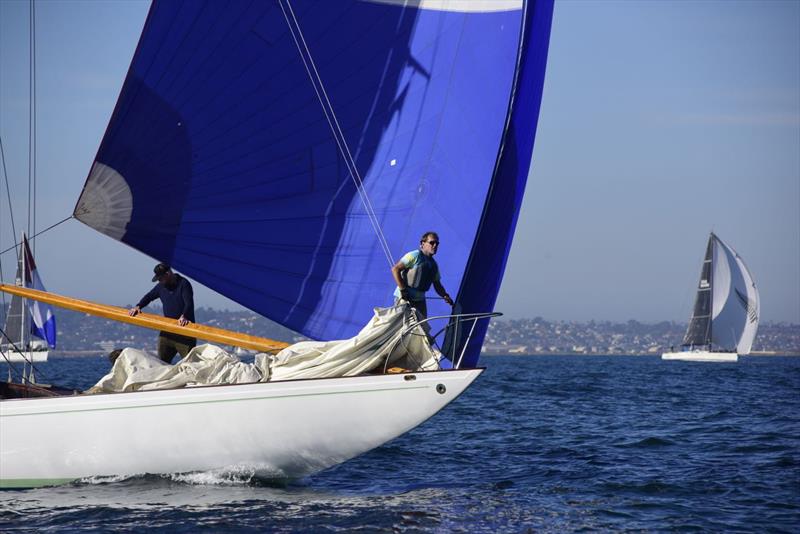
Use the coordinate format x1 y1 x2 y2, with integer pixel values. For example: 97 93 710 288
392 232 453 319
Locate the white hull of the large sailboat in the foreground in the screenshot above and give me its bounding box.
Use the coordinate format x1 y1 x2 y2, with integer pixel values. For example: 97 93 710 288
0 369 482 488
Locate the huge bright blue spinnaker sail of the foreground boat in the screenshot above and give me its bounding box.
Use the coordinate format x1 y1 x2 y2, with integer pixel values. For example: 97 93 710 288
75 0 552 364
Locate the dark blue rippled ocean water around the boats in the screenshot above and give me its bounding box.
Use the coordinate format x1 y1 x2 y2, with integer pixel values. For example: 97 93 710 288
0 356 800 533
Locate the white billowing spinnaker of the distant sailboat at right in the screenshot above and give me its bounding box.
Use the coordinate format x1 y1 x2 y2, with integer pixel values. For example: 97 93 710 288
711 234 760 354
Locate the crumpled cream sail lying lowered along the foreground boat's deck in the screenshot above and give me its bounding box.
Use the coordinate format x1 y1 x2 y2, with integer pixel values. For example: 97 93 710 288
86 304 441 393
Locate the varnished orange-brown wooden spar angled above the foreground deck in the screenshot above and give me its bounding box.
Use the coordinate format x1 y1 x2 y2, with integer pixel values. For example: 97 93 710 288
0 284 289 352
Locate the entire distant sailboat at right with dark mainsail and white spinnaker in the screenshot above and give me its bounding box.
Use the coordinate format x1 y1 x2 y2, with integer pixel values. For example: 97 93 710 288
661 232 761 362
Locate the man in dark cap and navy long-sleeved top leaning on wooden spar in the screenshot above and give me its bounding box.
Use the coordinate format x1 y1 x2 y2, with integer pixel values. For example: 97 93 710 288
129 263 197 363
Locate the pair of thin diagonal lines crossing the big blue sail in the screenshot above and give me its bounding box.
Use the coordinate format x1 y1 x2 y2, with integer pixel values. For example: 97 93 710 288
279 0 394 267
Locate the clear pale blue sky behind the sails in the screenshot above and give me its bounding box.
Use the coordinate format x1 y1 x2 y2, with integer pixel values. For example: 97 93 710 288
0 0 800 323
